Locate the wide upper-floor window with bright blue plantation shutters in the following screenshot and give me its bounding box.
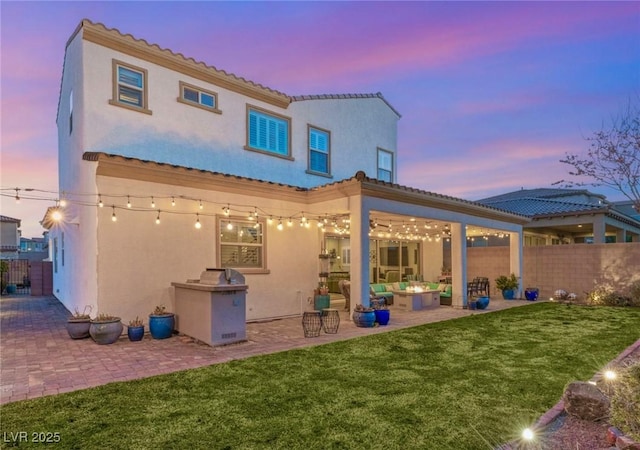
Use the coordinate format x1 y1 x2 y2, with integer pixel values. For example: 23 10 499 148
246 105 291 158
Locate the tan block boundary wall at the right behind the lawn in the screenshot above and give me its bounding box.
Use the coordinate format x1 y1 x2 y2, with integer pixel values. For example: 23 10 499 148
467 243 640 298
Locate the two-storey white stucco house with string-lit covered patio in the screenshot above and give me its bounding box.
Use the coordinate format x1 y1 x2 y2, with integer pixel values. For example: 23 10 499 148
43 20 528 320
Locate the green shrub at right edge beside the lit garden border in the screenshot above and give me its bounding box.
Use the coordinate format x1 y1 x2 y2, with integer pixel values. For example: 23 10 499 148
611 361 640 441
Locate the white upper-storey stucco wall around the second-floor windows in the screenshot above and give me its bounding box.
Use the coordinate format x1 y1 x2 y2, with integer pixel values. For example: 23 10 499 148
83 37 398 187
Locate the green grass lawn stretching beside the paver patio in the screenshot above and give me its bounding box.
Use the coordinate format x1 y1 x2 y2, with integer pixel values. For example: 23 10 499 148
1 303 640 450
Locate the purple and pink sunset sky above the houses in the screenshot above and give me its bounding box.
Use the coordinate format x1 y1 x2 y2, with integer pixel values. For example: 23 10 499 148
0 1 640 237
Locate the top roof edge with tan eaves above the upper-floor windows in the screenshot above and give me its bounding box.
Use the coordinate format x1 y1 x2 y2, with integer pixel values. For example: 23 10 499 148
56 19 400 120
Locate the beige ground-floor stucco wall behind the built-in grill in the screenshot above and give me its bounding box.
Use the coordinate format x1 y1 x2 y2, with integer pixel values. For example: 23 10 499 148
97 176 350 321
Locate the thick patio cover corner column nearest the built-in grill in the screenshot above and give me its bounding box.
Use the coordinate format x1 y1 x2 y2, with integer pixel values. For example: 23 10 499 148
349 195 369 310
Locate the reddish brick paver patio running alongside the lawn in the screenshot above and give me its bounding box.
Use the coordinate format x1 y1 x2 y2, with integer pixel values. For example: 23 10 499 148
0 296 528 404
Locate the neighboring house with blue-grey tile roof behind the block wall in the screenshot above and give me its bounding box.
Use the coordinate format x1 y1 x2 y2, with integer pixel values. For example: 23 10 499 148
478 188 640 245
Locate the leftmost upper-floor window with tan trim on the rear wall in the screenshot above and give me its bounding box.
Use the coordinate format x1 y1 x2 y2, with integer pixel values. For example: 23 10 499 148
109 59 151 114
